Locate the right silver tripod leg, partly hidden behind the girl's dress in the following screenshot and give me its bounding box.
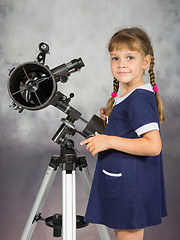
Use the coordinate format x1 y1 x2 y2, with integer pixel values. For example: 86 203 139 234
79 166 111 240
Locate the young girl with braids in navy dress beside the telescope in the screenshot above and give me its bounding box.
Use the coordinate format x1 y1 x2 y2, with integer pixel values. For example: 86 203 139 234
81 28 167 240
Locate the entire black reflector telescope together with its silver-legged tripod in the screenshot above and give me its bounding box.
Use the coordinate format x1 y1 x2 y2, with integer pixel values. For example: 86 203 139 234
7 42 110 240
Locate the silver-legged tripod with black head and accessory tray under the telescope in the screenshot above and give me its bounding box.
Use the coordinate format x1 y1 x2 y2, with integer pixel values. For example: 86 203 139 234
20 128 111 240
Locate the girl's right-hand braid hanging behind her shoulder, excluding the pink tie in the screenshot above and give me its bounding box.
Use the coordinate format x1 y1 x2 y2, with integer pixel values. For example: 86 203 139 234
148 53 164 122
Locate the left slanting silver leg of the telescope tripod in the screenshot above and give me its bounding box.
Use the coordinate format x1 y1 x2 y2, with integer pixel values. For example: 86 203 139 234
20 166 57 240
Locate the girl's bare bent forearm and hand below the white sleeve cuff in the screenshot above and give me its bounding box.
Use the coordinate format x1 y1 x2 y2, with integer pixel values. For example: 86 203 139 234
80 130 162 156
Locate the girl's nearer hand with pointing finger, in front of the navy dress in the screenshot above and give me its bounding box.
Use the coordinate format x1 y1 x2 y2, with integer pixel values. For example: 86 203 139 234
80 132 109 156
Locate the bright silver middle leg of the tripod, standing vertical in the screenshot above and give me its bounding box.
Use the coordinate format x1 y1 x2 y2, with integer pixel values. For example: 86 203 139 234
62 170 76 240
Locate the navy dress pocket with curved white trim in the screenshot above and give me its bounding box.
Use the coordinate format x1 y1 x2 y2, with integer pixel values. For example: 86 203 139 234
100 169 123 198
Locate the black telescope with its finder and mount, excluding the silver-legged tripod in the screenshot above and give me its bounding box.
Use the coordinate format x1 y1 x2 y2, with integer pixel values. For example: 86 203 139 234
7 42 104 140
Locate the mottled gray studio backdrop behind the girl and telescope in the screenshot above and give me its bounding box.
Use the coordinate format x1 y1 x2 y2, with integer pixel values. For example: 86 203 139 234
0 0 180 240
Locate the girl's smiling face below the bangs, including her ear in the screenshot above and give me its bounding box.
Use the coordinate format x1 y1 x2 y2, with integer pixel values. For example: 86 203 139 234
110 48 151 86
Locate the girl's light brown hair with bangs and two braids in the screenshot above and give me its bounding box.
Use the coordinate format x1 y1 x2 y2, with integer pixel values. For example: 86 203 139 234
106 28 164 122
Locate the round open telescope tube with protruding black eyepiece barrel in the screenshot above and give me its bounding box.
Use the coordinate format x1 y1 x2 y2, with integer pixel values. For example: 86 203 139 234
8 58 84 110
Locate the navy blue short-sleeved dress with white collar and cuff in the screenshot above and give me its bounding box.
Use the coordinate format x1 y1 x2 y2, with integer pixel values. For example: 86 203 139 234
85 84 167 229
